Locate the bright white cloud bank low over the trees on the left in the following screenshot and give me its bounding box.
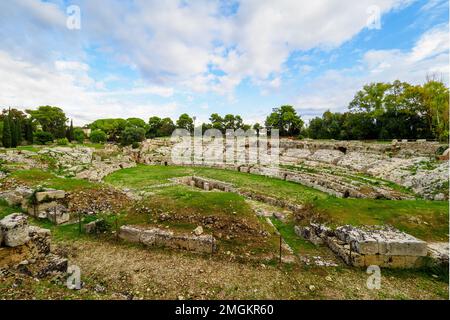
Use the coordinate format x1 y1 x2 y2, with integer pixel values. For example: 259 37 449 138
0 51 178 125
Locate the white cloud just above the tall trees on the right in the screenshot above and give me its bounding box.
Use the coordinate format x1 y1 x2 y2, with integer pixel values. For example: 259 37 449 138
296 25 449 118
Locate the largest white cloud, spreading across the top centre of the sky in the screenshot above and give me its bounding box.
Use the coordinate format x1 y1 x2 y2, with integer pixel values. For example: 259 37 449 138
23 0 409 95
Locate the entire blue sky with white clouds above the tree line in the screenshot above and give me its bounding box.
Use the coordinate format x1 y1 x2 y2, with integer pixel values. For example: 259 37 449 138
0 0 449 125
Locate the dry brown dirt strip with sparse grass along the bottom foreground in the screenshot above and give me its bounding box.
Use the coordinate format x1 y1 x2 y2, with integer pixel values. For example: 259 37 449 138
32 241 448 299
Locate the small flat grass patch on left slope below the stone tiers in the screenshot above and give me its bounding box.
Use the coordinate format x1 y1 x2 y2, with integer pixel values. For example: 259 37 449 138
10 169 100 191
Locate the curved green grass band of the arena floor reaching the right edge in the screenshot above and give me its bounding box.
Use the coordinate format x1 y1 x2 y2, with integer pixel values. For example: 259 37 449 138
106 165 449 241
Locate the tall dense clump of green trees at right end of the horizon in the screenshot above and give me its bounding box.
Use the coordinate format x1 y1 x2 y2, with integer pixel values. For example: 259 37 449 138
303 79 449 141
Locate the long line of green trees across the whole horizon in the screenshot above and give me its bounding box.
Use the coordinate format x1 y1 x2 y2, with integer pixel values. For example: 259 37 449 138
0 79 449 148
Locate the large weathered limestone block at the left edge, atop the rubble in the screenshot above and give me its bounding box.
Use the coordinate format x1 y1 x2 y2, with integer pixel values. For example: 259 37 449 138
0 213 30 247
